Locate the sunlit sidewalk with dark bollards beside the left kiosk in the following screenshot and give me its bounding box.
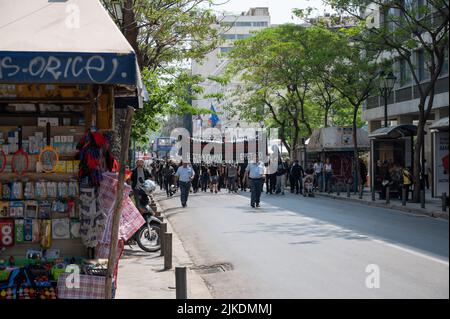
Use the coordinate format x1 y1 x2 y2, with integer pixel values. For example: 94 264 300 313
116 195 212 299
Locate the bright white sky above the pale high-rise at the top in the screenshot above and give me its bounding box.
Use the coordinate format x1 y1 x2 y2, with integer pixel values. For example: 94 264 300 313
208 0 332 24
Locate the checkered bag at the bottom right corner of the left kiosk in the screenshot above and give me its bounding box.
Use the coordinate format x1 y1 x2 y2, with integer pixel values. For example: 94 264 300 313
57 273 114 299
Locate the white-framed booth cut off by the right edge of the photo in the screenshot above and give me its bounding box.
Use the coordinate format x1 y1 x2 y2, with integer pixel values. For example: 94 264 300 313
430 117 449 197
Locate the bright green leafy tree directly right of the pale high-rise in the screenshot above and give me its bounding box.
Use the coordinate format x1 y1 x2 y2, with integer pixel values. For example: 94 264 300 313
227 24 338 158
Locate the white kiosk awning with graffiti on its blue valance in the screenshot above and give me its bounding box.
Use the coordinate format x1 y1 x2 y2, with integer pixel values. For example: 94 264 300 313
0 0 137 88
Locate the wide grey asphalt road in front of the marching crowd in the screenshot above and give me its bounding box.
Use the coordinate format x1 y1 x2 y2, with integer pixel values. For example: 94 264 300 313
157 191 449 298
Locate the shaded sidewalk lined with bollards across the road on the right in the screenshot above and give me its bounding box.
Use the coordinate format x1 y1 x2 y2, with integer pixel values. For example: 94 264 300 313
315 188 448 220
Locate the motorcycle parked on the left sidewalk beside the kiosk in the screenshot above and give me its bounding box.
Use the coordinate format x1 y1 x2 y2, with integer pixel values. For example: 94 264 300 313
128 180 162 253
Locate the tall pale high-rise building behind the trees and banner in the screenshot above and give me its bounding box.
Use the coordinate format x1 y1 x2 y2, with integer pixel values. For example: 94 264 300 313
191 7 270 136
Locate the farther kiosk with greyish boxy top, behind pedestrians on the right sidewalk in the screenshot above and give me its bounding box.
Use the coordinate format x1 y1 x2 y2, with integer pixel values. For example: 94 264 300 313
306 127 369 191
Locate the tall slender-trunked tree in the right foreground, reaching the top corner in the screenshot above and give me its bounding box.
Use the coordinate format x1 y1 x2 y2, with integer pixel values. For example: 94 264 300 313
328 0 449 201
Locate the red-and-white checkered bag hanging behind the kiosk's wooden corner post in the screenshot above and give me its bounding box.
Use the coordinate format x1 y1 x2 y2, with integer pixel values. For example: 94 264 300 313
100 174 145 244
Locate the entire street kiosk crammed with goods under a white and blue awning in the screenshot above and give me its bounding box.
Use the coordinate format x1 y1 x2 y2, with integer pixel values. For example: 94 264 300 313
0 0 144 299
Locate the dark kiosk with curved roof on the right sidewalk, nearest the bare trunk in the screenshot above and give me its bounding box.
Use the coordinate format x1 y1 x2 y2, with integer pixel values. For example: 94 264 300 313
369 124 417 198
